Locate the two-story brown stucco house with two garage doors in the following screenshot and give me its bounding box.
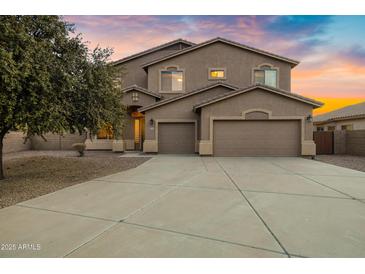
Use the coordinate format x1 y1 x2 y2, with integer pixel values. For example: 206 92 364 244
86 38 322 156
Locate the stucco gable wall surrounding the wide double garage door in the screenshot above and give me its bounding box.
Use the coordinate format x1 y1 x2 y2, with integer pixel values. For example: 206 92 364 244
200 88 313 140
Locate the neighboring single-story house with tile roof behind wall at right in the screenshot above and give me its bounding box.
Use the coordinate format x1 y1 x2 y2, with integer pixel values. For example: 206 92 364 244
313 102 365 131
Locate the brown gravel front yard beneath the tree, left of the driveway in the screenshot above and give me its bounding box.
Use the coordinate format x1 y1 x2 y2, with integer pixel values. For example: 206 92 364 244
0 151 150 208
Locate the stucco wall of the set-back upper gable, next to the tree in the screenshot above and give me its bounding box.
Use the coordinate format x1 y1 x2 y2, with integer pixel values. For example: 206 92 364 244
117 44 191 88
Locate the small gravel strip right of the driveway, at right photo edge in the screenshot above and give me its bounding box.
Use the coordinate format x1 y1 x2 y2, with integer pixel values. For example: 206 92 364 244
316 155 365 172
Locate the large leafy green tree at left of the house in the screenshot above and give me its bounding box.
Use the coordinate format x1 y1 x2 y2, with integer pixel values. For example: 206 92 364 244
0 16 125 179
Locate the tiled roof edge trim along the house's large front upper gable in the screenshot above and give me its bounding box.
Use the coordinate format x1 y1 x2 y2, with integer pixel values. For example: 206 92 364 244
142 37 299 69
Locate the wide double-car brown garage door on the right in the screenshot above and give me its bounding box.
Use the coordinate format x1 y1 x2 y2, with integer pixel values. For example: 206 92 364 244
213 120 300 156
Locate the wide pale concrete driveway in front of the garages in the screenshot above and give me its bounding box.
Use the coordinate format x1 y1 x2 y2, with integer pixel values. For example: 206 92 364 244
0 156 365 257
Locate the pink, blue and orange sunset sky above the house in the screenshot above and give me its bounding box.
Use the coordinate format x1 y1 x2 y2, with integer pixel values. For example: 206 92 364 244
64 16 365 114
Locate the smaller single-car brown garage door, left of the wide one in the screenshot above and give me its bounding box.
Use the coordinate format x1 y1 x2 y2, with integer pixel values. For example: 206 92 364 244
158 123 195 154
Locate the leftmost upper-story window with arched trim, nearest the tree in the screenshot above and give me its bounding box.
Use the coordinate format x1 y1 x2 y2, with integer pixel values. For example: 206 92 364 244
160 67 184 92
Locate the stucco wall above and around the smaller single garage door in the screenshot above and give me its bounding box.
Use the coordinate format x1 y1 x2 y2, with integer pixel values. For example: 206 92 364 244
145 87 231 140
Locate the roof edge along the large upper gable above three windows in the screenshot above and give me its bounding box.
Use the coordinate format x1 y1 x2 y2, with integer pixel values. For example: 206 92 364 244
142 37 299 68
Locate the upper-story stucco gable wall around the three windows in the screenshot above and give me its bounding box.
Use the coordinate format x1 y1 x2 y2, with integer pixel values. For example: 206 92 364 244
148 42 291 91
